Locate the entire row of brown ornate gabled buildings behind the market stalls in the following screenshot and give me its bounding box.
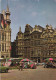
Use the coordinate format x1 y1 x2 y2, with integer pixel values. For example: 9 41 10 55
15 24 56 62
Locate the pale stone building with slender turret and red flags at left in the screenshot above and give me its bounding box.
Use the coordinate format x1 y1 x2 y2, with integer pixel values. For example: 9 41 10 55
0 6 11 58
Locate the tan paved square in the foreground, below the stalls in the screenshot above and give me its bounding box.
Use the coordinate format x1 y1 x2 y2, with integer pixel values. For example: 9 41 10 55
0 66 56 80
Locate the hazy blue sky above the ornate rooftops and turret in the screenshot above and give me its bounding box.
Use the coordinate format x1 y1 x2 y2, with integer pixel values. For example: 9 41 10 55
0 0 56 41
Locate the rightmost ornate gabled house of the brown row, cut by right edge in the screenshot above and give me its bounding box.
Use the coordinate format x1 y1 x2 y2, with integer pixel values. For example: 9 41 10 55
41 25 56 61
